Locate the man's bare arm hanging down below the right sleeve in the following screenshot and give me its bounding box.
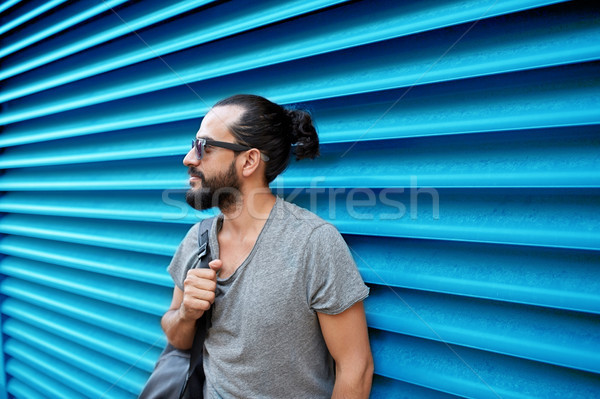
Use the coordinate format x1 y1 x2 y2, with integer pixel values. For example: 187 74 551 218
317 302 373 399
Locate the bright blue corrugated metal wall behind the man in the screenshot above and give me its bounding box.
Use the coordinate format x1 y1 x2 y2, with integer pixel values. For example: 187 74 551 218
0 0 600 398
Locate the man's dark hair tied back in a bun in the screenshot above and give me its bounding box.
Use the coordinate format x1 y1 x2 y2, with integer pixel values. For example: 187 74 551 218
214 94 319 183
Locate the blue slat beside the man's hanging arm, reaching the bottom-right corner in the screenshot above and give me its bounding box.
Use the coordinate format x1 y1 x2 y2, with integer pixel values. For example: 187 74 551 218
370 330 600 399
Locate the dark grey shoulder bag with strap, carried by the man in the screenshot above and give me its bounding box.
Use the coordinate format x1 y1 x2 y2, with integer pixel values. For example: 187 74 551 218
138 218 214 399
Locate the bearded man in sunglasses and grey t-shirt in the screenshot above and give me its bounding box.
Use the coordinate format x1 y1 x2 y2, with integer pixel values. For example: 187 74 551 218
162 95 373 398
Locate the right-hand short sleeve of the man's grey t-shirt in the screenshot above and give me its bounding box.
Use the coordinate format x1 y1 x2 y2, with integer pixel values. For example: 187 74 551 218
306 224 369 314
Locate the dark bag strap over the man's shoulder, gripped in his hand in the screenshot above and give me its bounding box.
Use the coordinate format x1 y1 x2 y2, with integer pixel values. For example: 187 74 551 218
179 217 215 399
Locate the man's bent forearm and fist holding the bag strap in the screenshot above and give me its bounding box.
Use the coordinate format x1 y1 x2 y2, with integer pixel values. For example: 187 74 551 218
160 260 222 349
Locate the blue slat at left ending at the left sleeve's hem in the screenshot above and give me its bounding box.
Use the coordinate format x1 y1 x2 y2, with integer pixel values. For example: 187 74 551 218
0 236 173 286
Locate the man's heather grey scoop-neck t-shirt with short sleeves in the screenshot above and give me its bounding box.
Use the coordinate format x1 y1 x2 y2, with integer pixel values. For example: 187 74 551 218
168 198 369 398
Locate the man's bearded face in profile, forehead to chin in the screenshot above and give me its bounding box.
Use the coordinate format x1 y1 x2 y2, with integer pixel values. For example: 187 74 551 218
183 106 242 212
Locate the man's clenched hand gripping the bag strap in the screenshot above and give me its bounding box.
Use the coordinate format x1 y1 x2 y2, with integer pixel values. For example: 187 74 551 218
179 259 223 321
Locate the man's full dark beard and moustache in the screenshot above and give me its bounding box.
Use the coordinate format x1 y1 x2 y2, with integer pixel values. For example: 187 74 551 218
185 162 241 212
